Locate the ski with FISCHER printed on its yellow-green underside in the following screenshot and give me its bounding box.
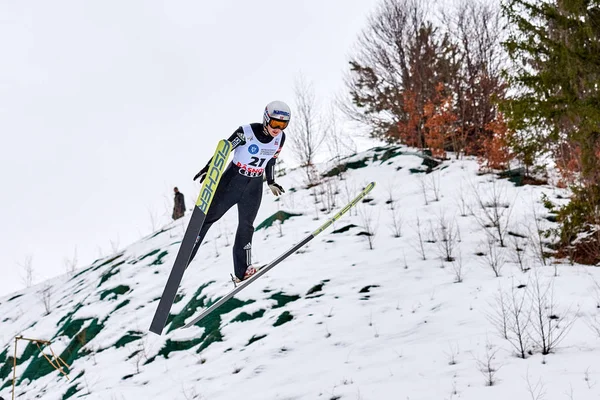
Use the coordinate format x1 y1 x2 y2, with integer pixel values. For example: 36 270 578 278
150 140 231 335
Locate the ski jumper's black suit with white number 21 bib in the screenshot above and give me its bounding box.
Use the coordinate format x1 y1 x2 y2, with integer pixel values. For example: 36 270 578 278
188 123 285 279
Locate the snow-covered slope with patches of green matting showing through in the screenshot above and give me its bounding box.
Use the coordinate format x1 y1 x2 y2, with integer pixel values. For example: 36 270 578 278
0 148 600 400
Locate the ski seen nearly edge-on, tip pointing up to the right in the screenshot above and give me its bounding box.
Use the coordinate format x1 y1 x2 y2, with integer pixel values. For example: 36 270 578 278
183 182 375 328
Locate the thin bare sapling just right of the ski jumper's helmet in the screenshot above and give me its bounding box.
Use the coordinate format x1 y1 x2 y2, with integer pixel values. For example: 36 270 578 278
288 77 325 186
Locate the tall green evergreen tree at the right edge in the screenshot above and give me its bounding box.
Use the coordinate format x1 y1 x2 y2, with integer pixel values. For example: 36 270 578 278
503 0 600 261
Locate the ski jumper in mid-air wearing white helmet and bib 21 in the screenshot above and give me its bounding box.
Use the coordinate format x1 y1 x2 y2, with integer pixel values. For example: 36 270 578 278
190 101 291 282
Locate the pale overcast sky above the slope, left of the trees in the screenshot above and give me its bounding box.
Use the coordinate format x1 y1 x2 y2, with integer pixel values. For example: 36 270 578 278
0 0 378 295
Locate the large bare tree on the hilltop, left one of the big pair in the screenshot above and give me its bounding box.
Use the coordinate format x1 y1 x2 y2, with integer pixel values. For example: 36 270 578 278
340 0 455 147
